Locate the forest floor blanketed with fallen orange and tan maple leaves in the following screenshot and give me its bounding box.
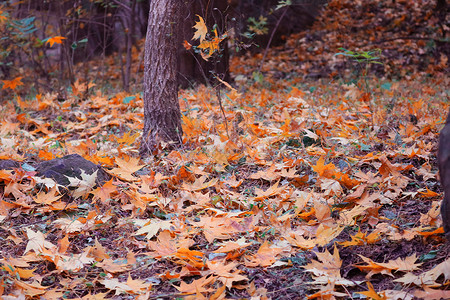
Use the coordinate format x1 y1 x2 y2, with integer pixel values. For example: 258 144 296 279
0 1 450 299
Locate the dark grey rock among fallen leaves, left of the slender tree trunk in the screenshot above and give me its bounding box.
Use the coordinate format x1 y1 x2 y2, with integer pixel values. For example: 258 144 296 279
36 154 111 186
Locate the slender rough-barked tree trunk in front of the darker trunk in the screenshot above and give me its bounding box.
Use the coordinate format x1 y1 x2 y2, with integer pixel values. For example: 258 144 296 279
140 0 183 155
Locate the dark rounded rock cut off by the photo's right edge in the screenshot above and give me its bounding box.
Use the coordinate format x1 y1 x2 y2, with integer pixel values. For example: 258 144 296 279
438 112 450 239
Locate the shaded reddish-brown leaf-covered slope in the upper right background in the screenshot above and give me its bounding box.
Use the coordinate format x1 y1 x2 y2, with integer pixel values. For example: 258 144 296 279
236 0 449 81
